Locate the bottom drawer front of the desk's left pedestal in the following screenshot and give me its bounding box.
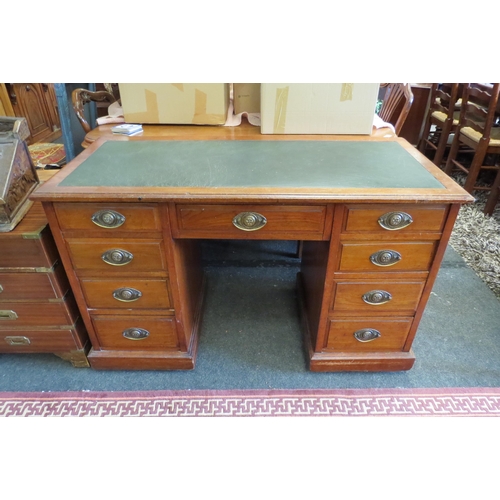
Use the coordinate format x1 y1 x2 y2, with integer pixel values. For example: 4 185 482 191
92 316 178 351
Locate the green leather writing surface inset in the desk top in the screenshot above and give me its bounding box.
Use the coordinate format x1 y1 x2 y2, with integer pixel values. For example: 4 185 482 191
60 141 443 189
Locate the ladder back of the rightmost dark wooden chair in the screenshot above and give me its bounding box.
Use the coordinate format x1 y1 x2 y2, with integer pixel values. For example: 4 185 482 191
459 83 500 141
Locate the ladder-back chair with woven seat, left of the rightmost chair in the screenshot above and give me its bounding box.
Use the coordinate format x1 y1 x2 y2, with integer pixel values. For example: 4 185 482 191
418 83 460 167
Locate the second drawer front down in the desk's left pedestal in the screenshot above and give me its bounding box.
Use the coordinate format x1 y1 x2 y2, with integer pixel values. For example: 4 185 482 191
66 238 166 273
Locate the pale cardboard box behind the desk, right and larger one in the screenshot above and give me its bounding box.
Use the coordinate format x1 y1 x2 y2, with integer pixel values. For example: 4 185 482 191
260 83 379 135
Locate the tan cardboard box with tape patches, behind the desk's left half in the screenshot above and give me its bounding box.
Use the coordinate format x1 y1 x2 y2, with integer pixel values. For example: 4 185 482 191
118 83 229 125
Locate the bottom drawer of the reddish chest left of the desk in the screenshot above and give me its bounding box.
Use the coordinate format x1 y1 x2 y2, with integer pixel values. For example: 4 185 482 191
0 328 82 353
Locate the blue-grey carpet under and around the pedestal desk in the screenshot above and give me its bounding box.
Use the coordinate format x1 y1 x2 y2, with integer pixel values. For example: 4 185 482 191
0 241 500 392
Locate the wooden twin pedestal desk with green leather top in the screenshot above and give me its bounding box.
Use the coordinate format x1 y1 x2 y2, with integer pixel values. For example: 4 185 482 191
32 136 472 371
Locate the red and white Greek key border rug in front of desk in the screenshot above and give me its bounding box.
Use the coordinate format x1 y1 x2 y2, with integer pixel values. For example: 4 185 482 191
0 388 500 417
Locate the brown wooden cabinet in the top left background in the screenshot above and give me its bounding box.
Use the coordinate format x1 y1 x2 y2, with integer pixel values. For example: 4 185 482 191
6 83 62 144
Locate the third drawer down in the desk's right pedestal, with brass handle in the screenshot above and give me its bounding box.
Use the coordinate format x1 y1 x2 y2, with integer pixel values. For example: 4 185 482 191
332 281 425 316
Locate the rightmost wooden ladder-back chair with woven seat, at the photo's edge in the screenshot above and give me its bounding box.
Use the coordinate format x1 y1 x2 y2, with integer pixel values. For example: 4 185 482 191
444 83 500 193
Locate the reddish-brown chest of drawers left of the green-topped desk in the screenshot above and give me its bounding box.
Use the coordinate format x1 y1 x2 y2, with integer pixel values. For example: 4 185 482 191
0 203 89 367
